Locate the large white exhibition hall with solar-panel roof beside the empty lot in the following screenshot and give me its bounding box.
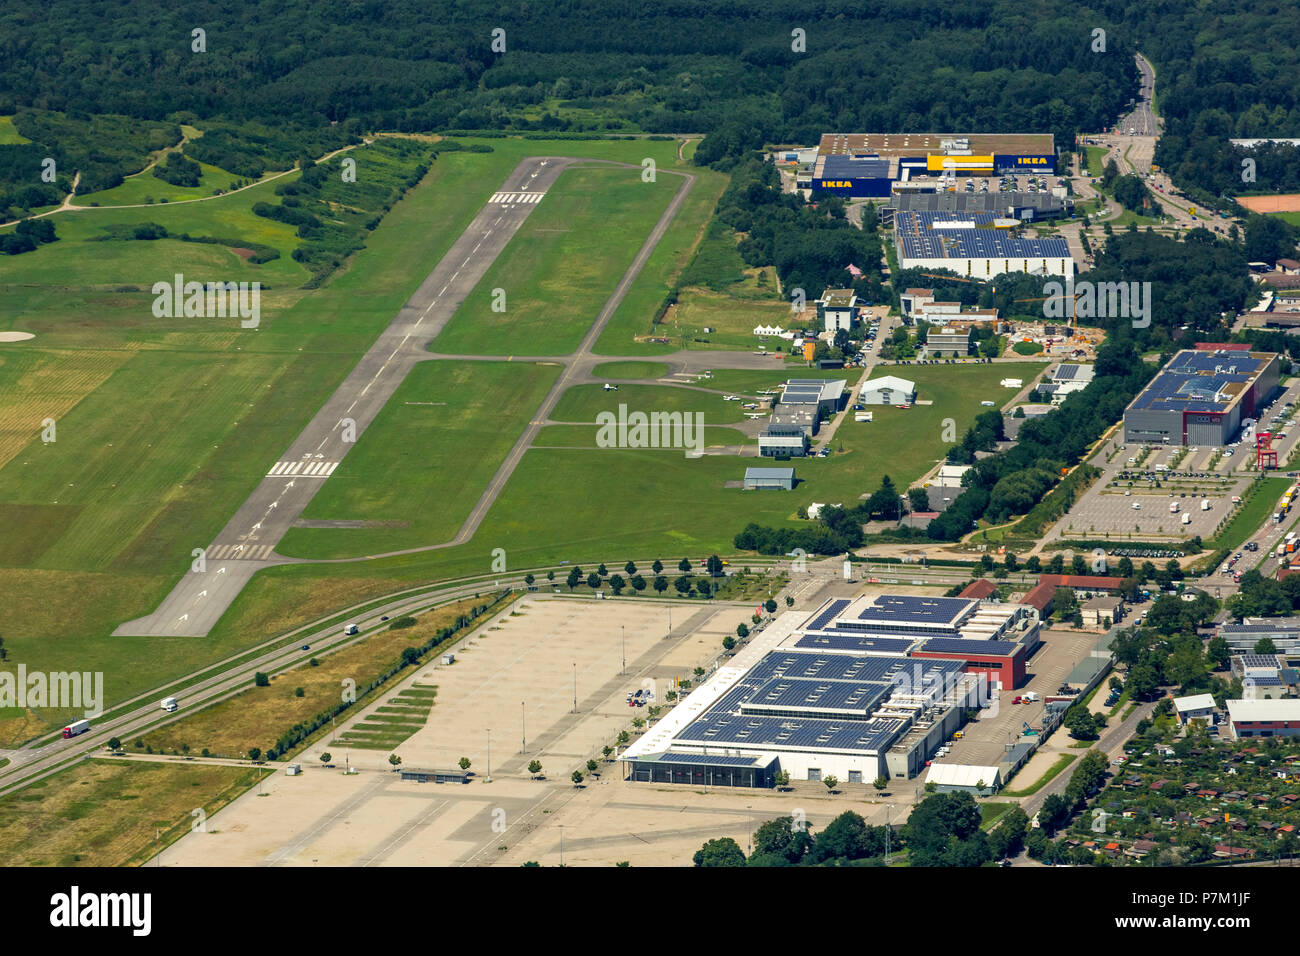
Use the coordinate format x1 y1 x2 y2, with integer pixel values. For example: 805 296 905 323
619 594 1039 787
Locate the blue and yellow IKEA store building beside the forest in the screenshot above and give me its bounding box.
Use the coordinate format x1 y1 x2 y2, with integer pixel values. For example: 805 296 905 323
813 133 1056 199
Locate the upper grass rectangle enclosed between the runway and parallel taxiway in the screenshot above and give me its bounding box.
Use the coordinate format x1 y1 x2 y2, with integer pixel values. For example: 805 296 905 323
432 166 680 355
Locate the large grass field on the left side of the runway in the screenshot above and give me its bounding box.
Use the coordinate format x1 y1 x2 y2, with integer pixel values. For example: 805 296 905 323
0 132 689 700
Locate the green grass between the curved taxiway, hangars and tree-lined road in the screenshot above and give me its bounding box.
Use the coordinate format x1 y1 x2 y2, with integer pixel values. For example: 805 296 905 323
195 363 1041 655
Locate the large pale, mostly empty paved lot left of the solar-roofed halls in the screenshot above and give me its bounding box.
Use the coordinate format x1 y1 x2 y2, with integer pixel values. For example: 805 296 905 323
160 598 753 866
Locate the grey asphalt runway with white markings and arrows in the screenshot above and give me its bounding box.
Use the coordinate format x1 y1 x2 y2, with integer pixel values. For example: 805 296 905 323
113 156 573 637
